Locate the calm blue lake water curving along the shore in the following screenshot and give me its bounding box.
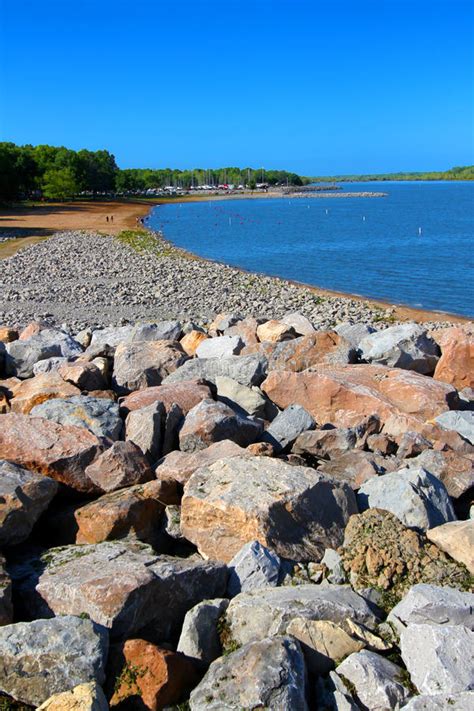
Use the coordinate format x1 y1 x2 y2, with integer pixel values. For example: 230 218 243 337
148 182 474 316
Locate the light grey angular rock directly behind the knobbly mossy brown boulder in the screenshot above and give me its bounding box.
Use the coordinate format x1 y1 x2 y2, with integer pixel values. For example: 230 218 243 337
357 467 456 531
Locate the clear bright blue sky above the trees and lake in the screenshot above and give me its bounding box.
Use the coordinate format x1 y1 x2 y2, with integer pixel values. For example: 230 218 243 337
0 0 474 175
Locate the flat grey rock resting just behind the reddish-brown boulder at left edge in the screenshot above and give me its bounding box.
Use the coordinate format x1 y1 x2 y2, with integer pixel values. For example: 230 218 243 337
26 394 123 441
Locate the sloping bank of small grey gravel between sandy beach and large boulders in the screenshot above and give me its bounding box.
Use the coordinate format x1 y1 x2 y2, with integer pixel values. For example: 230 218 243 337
0 231 458 331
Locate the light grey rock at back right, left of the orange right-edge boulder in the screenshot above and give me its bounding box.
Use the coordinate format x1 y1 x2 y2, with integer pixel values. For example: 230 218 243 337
359 323 440 375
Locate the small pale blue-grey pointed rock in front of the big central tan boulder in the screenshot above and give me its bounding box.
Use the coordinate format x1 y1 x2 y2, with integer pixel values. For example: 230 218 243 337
227 541 282 597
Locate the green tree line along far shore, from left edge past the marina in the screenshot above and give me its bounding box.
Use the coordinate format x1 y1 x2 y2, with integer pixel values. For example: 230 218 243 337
0 143 309 202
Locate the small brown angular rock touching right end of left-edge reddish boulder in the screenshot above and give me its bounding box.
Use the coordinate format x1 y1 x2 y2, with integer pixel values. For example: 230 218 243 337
85 441 153 491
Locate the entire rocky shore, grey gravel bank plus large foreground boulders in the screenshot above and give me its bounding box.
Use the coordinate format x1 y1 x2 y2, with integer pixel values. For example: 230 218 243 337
0 308 474 711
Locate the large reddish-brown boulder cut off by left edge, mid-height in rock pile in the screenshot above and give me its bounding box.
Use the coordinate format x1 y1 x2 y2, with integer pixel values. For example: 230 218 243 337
0 413 103 493
